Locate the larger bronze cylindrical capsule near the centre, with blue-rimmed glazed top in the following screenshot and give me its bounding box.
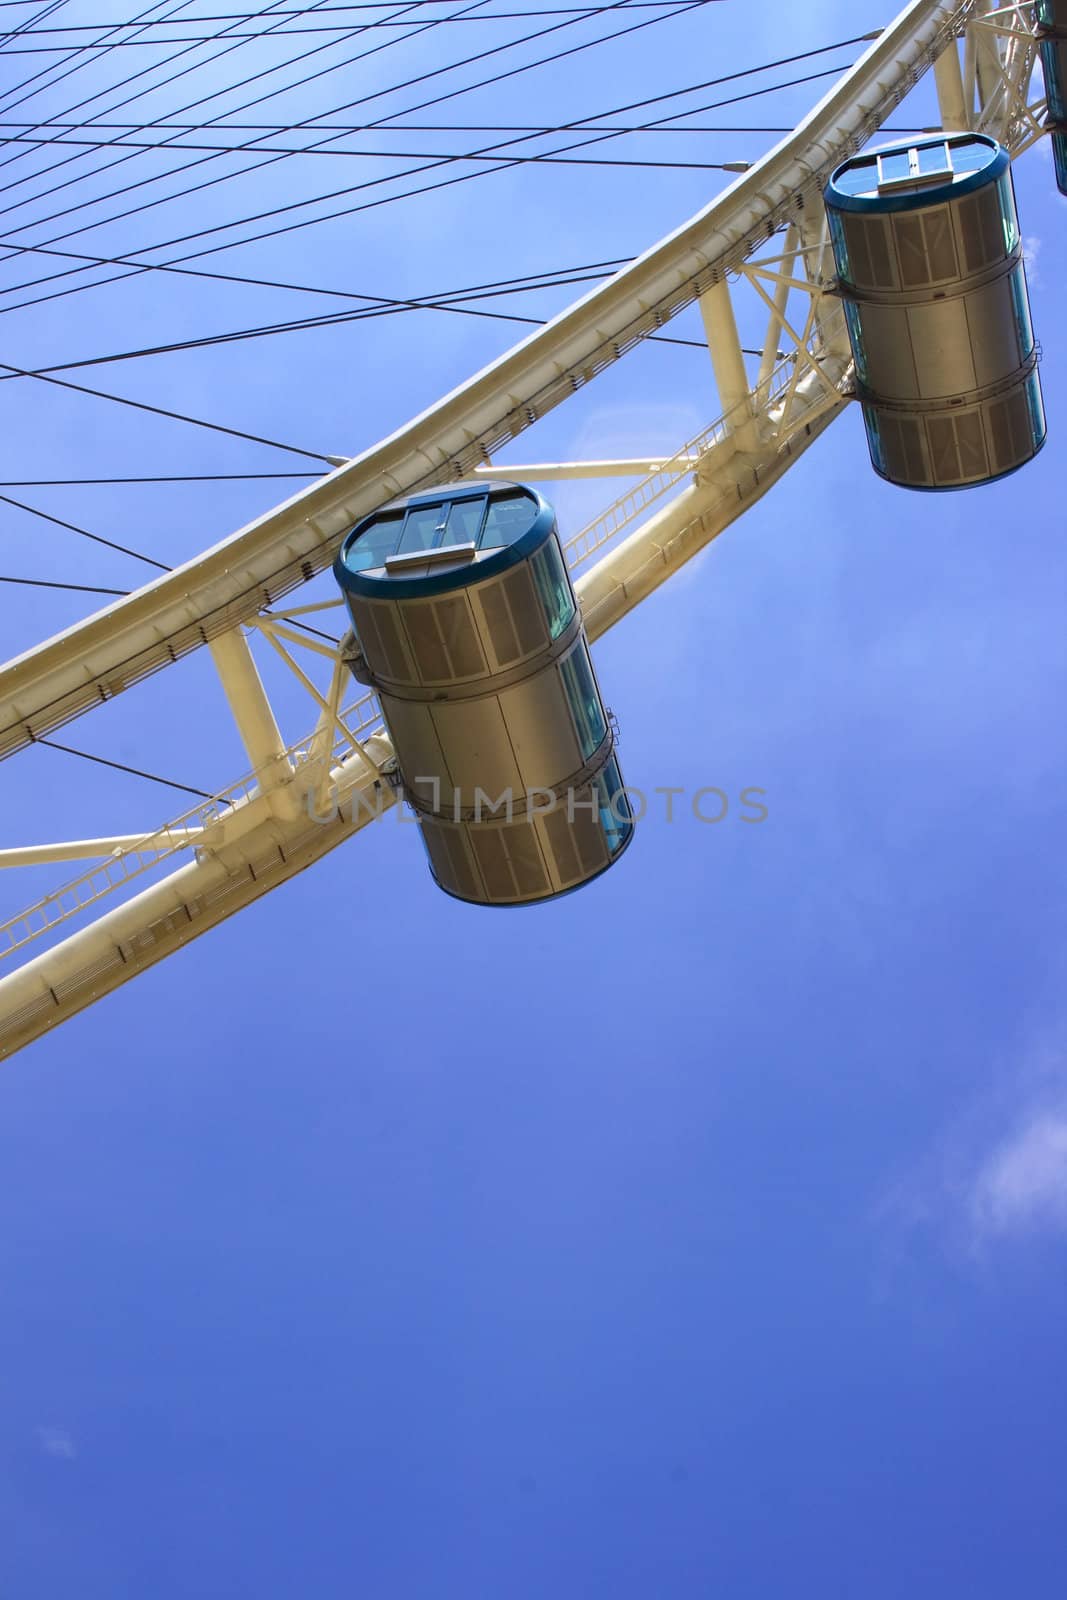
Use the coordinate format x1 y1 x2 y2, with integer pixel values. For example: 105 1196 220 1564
334 483 633 906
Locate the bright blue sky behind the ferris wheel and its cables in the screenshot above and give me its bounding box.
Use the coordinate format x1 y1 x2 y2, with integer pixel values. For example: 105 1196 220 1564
0 0 1067 1600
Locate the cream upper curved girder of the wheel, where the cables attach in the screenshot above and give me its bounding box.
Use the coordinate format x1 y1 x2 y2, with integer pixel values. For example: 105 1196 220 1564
0 0 976 757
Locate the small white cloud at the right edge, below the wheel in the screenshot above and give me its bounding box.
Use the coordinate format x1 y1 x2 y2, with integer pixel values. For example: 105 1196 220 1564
971 1112 1067 1234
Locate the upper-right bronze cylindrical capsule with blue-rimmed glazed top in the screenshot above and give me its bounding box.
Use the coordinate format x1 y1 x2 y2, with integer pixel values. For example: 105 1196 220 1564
824 133 1045 490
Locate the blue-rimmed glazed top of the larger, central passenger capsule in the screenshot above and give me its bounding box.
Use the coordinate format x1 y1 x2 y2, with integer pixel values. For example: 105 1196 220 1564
334 480 555 600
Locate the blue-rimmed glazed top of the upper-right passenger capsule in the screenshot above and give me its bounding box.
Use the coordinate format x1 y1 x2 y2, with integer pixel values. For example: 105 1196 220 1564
824 133 1009 213
